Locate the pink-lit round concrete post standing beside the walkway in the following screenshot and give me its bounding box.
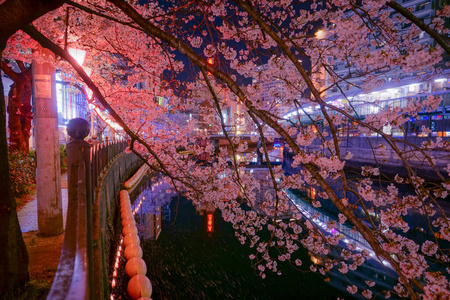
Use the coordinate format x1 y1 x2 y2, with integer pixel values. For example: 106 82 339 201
32 48 63 236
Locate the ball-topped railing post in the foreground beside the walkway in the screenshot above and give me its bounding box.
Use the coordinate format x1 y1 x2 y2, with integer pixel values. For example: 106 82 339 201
47 119 94 300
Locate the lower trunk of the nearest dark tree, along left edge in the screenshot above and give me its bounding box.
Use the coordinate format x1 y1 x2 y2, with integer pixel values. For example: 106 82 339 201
0 45 29 294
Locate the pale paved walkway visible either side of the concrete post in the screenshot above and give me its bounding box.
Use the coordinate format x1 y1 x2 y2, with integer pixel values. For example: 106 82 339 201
17 172 68 232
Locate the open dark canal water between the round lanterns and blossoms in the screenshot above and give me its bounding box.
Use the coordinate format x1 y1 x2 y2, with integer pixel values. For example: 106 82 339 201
142 197 351 300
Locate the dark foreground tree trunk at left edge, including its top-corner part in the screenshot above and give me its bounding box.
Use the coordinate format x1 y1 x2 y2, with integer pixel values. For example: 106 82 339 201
0 0 64 297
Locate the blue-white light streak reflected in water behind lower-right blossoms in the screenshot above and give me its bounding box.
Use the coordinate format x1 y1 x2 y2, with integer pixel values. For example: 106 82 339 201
253 169 396 299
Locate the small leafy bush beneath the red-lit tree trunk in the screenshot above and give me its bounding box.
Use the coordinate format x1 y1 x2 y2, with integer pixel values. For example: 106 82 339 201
8 150 36 196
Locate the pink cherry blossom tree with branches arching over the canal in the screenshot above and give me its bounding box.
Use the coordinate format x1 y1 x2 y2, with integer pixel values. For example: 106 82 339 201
4 0 450 299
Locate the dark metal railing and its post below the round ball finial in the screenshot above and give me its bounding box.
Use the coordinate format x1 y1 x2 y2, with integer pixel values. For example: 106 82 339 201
47 139 131 300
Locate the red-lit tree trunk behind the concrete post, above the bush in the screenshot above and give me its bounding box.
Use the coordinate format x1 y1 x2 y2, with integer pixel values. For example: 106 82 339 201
1 61 33 154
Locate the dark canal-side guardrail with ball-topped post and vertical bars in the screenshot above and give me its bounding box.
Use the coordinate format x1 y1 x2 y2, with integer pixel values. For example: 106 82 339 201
47 119 142 300
